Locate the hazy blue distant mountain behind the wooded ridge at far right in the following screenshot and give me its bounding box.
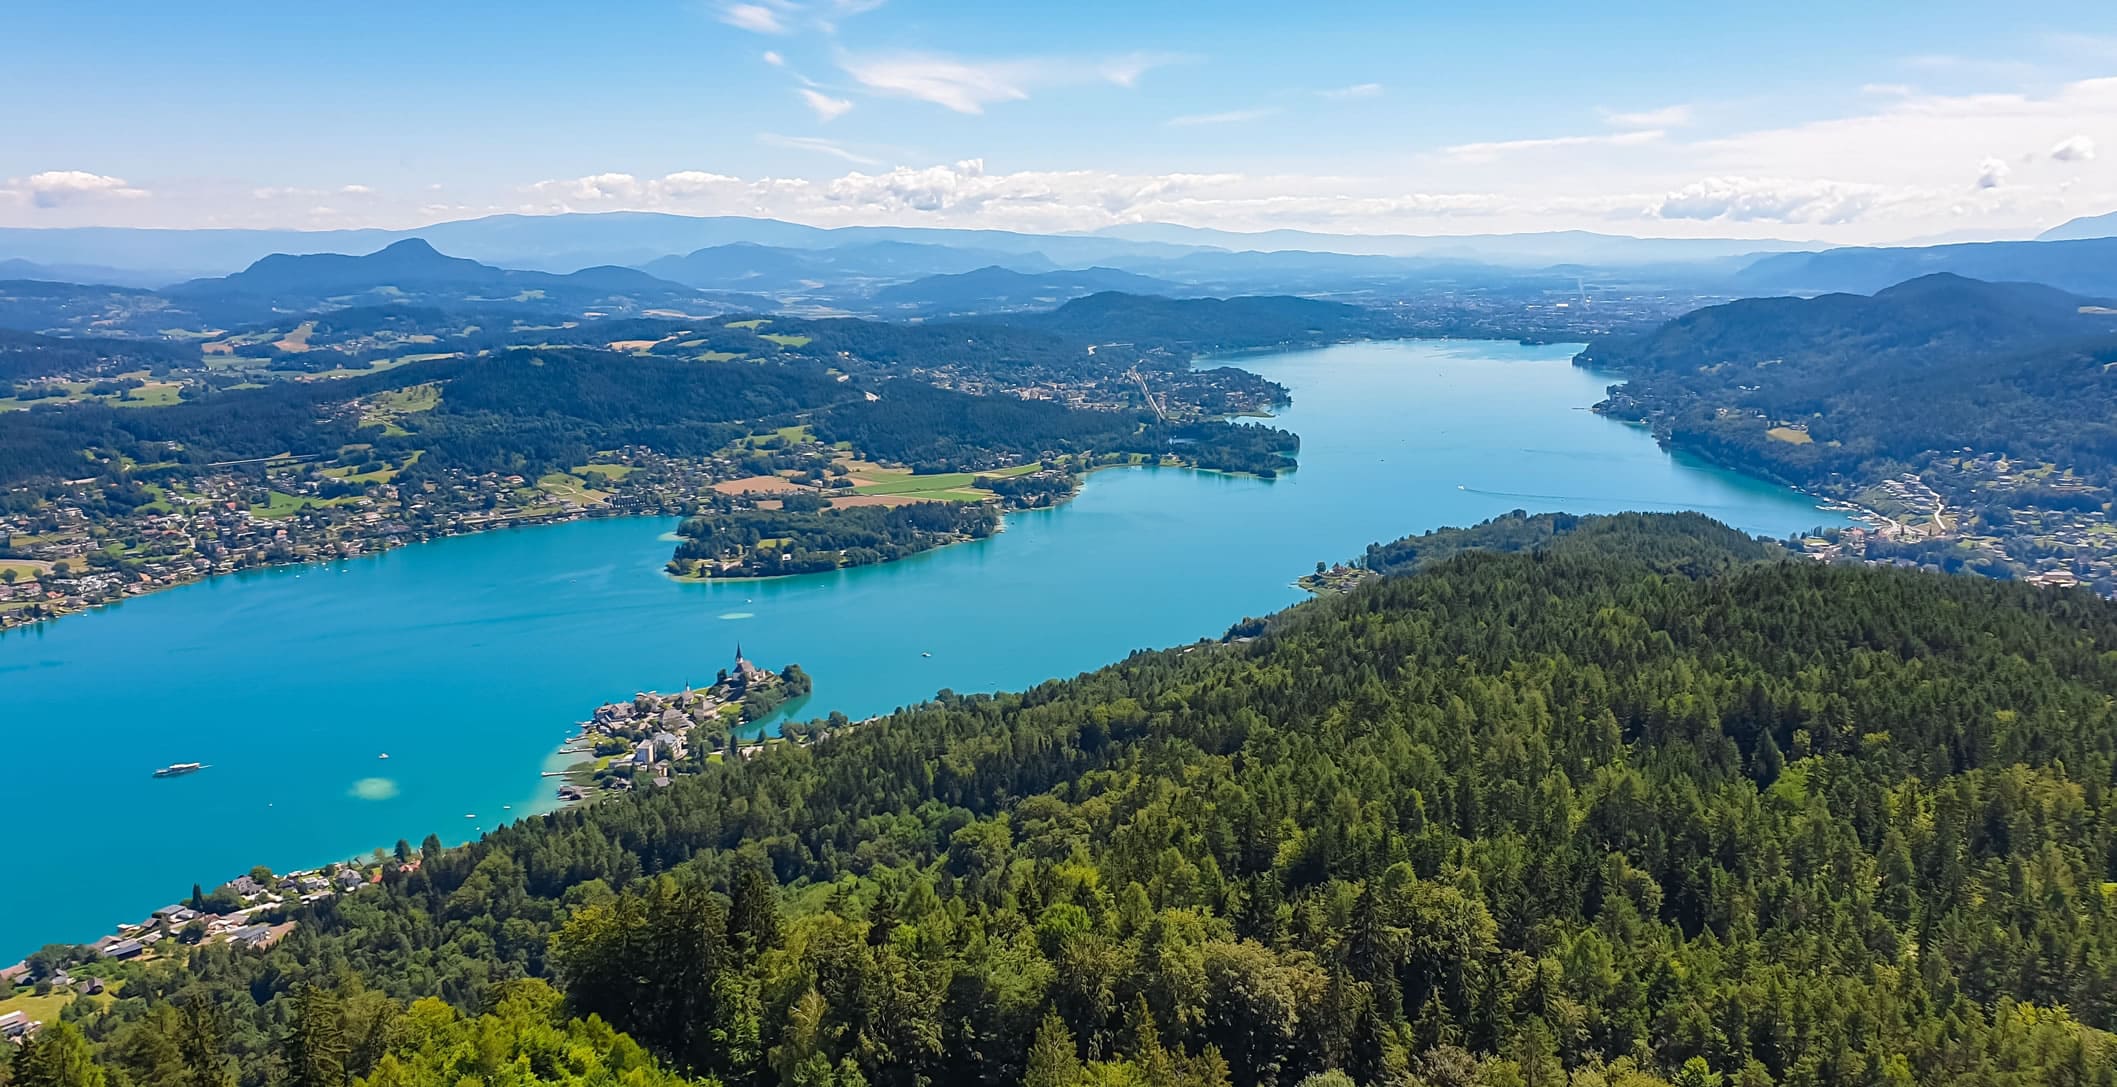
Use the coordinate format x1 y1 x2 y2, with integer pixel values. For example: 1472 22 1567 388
1732 237 2117 297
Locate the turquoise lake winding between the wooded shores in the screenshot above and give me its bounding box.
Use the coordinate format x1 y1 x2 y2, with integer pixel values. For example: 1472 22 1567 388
0 341 1844 960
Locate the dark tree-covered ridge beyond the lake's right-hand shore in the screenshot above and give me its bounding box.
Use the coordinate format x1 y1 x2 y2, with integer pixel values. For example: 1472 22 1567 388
1575 275 2117 489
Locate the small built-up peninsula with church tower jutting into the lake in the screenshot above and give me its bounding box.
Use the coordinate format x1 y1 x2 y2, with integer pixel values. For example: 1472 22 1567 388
557 646 813 803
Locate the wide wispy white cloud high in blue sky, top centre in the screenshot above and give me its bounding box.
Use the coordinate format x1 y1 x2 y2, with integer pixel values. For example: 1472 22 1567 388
838 53 1177 114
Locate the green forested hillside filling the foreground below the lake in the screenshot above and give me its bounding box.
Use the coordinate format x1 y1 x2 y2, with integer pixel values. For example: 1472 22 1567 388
40 517 2117 1087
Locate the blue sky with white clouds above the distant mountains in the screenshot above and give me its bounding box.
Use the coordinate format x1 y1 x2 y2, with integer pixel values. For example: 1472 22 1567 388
0 0 2117 244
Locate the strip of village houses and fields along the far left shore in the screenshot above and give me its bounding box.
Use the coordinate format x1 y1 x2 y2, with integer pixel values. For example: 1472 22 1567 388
0 432 1071 629
